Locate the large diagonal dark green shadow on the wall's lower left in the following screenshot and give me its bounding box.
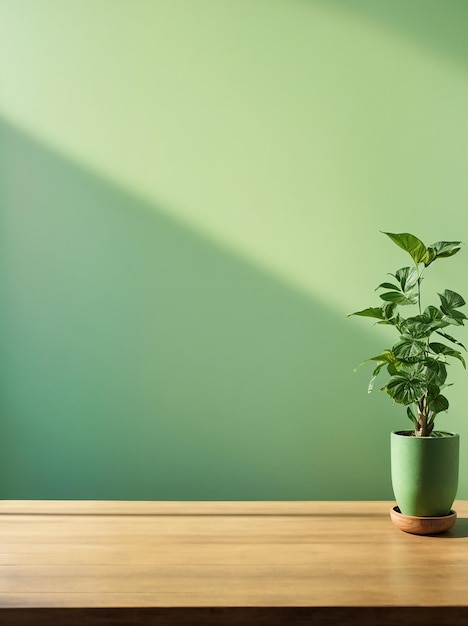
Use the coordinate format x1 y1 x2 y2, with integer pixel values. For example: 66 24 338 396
0 119 406 500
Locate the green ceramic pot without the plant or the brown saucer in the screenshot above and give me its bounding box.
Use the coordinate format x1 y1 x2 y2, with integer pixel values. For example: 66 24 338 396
391 431 460 517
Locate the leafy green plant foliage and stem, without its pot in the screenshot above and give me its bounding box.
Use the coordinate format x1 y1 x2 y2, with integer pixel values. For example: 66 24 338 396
348 233 467 437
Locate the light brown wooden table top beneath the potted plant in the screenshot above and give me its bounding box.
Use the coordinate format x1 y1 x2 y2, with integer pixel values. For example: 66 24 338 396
0 501 468 626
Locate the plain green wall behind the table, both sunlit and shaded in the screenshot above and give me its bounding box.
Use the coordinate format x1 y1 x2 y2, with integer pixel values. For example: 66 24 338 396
0 0 468 499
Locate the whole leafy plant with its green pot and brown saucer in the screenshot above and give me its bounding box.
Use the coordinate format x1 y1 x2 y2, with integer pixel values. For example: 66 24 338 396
351 233 467 534
